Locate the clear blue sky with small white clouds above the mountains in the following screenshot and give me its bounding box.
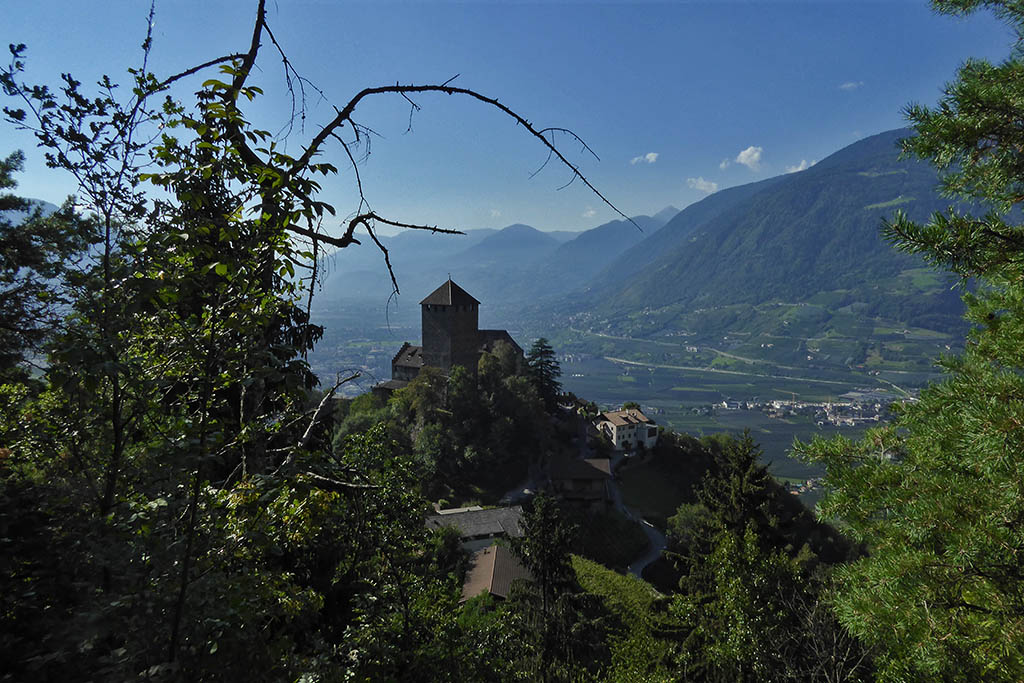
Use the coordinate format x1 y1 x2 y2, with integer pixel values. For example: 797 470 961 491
0 0 1014 230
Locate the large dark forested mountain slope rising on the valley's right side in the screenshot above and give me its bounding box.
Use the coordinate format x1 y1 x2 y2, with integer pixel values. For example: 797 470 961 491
581 130 962 329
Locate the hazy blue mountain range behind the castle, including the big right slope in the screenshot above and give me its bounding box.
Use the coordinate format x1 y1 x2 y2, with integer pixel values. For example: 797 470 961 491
321 130 963 344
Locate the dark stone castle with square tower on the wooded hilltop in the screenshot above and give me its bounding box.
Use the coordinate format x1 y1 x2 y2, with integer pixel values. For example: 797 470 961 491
375 278 522 391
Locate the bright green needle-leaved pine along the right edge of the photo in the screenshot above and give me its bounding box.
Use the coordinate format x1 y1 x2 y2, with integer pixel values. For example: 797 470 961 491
799 0 1024 681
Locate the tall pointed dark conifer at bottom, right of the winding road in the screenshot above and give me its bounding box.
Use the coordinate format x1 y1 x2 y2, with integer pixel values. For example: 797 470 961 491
673 434 797 680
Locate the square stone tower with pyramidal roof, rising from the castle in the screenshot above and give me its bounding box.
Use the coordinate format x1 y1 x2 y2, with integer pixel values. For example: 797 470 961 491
420 278 480 373
